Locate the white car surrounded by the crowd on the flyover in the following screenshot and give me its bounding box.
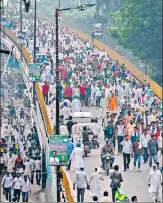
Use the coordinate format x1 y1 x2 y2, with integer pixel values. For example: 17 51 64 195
72 112 94 128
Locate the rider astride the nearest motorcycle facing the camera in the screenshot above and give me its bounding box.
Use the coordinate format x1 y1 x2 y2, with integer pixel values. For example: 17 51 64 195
101 140 114 168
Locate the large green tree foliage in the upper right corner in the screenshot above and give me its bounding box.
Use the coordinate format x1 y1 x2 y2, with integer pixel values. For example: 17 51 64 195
109 0 162 83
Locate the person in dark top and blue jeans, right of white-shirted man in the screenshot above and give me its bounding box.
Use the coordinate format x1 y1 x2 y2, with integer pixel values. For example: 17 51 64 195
133 137 142 172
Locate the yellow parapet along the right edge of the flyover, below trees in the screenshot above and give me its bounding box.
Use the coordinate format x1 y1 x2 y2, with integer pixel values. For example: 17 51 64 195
62 24 163 99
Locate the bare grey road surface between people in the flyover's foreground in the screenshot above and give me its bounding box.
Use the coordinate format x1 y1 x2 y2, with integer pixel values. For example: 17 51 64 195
69 107 151 202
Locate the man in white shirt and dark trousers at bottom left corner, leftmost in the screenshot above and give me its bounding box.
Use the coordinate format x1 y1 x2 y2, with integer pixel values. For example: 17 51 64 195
2 171 13 202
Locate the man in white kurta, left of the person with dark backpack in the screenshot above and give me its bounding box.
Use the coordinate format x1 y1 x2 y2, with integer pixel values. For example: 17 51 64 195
89 168 104 198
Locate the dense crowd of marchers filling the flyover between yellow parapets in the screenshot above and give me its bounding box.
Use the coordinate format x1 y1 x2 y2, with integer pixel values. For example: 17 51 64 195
3 3 163 202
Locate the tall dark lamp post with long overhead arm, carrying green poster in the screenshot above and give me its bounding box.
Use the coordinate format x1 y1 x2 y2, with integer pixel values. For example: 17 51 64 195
55 3 96 202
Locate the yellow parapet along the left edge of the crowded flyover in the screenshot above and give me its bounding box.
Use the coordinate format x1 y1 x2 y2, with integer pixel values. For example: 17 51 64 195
2 28 75 202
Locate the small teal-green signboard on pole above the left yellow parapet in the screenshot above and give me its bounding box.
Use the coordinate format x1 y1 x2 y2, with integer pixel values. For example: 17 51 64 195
28 63 41 81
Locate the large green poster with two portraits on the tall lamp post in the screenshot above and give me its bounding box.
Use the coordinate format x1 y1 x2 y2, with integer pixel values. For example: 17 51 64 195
49 135 68 166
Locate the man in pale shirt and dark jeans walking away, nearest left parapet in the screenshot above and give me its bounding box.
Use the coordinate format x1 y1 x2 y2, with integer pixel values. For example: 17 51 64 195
73 166 89 202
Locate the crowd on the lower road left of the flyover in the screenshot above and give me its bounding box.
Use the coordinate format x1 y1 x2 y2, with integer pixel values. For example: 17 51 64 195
0 91 41 202
